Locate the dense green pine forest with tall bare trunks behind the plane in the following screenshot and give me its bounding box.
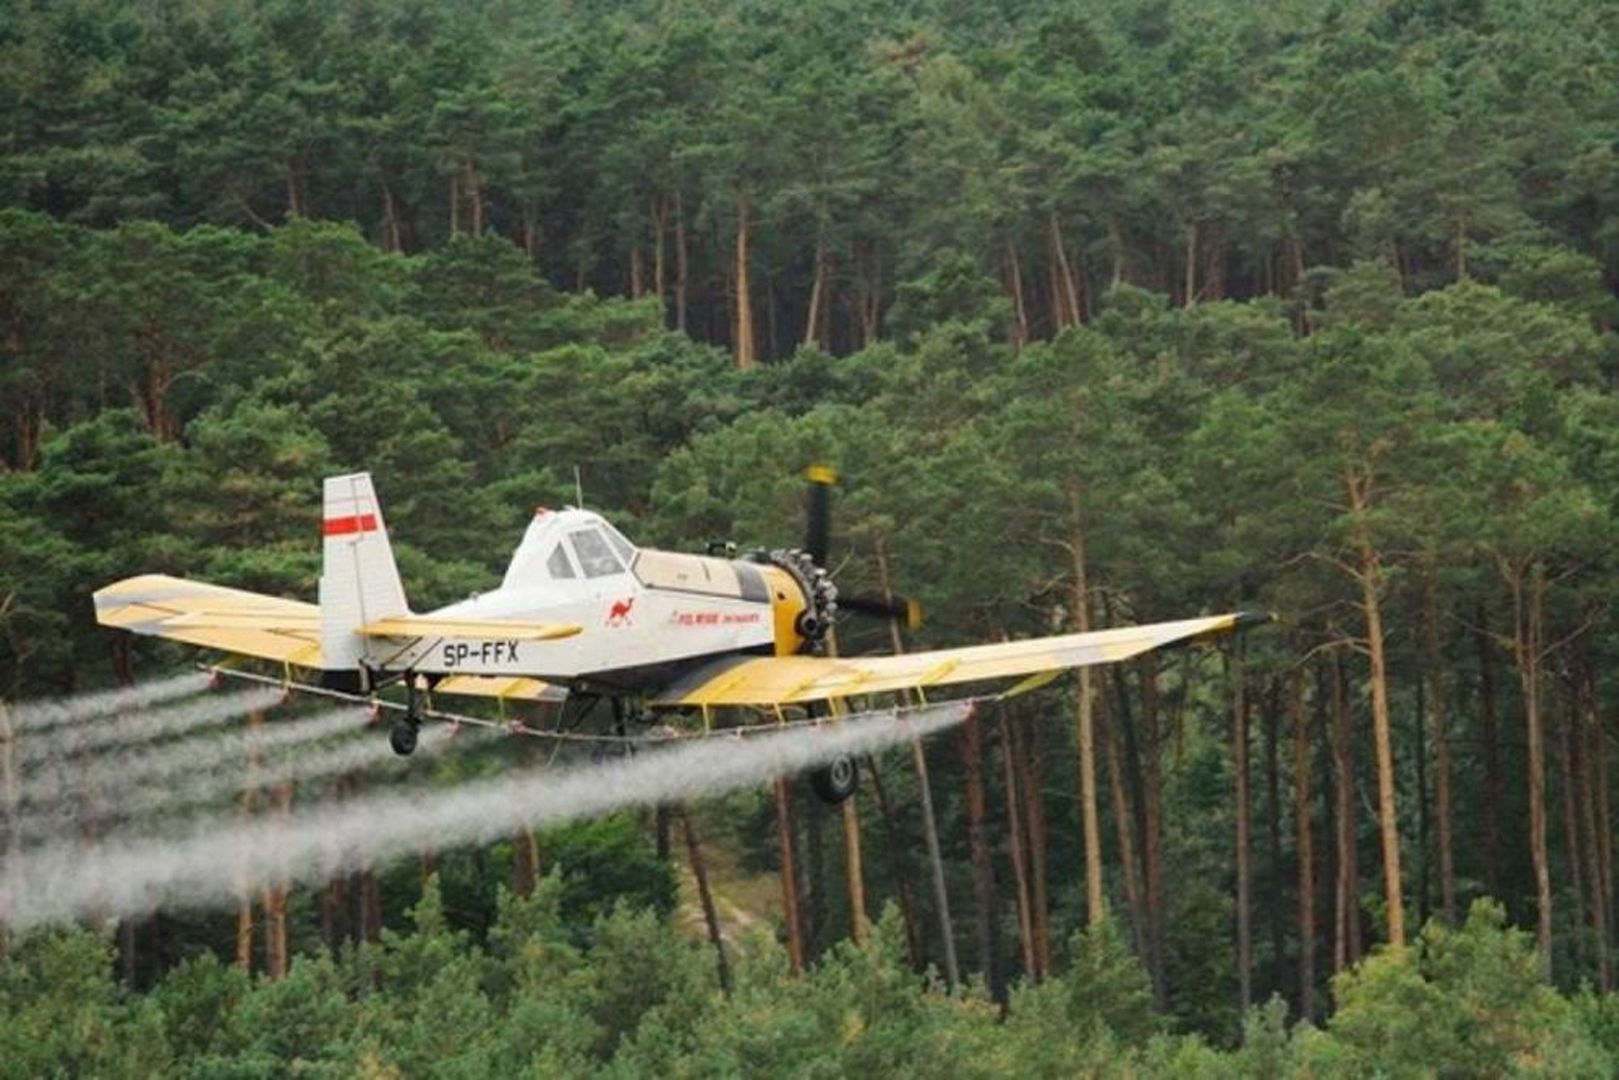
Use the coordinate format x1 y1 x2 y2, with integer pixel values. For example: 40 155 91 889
0 0 1619 1077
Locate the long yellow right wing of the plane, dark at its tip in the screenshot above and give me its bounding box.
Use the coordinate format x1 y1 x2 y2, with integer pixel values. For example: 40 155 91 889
652 614 1268 706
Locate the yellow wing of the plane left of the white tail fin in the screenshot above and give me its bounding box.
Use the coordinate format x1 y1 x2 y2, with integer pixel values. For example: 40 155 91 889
96 573 321 667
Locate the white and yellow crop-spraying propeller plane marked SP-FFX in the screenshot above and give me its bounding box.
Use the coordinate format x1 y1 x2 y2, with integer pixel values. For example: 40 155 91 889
96 468 1264 801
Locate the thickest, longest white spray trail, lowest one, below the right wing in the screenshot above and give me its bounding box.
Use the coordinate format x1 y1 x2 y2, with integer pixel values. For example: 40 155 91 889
0 701 973 929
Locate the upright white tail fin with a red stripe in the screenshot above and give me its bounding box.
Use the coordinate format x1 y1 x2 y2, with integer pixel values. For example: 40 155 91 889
321 473 410 674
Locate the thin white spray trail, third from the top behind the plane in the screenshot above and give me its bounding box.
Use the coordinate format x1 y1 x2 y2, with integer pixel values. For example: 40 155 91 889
21 706 372 806
